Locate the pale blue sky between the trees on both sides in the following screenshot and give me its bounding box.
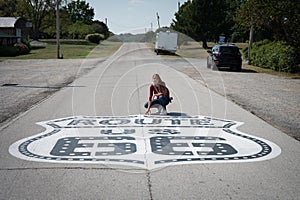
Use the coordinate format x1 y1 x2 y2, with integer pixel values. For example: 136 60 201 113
86 0 187 34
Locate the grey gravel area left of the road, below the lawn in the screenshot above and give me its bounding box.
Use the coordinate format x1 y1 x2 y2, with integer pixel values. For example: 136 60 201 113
0 58 105 126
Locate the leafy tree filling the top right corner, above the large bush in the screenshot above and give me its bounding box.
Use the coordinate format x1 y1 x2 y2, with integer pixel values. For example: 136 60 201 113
235 0 300 46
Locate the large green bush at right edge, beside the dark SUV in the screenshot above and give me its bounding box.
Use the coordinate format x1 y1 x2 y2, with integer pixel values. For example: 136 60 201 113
242 40 299 72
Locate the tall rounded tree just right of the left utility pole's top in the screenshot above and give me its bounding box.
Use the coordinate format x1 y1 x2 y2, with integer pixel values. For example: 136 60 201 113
64 0 95 24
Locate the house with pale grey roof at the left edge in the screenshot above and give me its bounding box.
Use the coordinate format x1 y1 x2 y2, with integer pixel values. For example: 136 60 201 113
0 17 32 46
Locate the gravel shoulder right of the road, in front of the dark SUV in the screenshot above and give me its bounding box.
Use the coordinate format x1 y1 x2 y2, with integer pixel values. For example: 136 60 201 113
165 58 300 141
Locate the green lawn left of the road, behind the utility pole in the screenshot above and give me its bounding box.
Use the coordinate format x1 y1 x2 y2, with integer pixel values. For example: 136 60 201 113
0 40 122 59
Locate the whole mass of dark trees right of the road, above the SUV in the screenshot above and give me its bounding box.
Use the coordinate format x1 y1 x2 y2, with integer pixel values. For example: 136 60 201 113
171 0 300 48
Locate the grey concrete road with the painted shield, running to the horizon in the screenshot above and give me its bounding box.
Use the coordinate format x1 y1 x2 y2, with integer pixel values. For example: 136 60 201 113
0 43 300 199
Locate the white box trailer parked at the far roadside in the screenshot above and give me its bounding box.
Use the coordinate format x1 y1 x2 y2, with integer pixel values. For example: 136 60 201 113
154 31 178 55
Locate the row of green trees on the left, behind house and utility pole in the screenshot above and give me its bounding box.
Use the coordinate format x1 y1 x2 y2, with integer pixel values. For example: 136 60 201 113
0 0 111 39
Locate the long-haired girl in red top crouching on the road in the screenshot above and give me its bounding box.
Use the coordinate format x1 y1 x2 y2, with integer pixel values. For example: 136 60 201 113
145 74 170 115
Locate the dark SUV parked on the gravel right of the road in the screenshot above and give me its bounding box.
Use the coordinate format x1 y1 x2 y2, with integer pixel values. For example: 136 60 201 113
207 44 242 71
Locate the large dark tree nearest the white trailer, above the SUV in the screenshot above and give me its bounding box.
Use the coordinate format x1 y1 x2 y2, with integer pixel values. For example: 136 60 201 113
171 0 232 48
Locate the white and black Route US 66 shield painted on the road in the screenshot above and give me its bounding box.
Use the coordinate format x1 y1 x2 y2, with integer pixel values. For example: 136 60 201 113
9 115 281 170
